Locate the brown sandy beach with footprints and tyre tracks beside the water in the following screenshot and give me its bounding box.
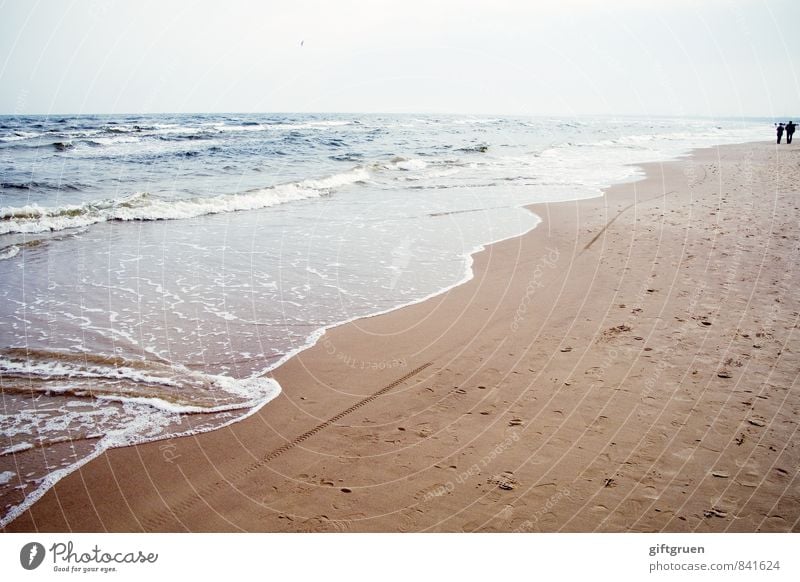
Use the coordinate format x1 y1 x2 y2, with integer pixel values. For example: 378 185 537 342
5 143 800 532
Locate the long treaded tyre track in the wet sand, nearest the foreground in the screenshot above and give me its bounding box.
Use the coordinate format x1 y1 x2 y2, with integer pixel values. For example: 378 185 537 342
142 362 433 533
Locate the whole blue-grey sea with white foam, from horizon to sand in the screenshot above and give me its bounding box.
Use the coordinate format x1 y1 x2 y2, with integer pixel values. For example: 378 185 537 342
0 114 772 525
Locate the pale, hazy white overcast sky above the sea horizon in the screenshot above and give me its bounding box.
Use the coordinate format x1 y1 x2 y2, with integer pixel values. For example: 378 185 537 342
0 0 800 117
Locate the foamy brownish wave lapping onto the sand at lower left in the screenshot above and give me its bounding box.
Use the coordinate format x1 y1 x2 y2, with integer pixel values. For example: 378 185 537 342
0 349 281 528
